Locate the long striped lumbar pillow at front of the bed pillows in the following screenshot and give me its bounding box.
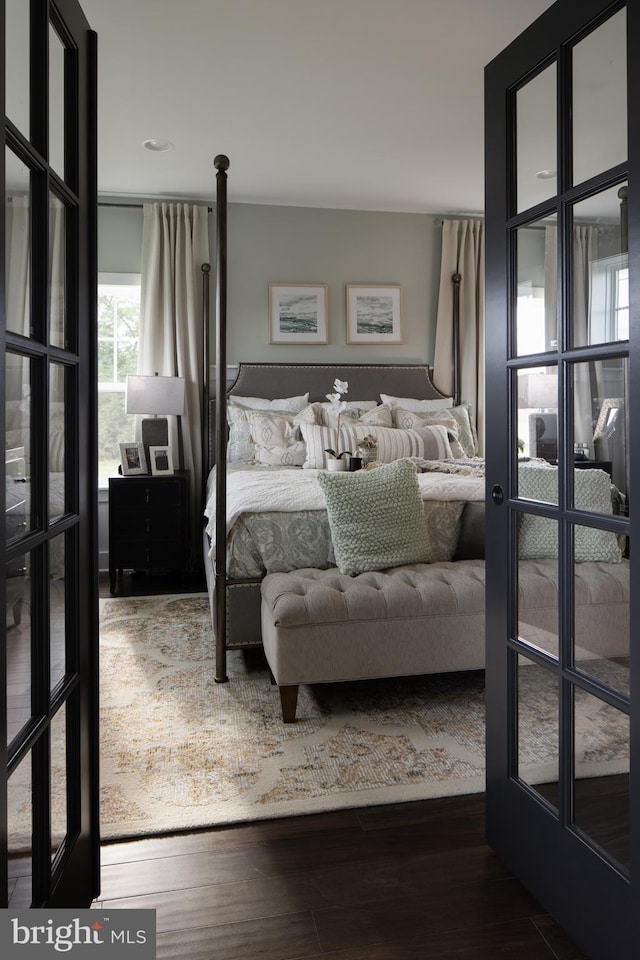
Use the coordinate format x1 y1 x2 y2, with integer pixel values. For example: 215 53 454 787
300 420 453 470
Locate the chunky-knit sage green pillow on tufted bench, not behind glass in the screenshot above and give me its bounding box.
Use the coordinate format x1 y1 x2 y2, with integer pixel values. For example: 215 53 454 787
318 460 430 576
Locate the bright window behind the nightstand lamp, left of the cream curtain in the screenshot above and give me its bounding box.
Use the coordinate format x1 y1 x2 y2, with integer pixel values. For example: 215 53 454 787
98 273 140 485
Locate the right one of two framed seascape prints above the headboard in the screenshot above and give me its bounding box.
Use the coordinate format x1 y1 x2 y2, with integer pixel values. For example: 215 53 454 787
347 283 402 343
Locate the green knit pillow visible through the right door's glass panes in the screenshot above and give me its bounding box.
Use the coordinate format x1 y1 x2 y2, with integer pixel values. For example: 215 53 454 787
518 463 622 563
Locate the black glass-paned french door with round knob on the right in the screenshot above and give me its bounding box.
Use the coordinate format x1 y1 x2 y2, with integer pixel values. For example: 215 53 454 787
485 0 640 960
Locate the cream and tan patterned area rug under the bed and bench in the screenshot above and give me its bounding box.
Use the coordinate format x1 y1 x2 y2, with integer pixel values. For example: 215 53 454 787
100 594 628 840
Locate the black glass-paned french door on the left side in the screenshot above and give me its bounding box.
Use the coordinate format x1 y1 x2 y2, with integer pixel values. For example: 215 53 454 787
0 0 99 909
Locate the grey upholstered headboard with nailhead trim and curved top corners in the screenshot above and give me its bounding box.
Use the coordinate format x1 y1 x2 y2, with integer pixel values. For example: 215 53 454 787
207 363 444 467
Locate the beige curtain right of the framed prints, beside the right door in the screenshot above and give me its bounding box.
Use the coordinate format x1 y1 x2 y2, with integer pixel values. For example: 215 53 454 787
433 220 485 454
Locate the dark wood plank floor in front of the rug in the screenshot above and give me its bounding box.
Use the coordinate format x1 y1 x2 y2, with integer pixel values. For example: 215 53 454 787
99 795 585 960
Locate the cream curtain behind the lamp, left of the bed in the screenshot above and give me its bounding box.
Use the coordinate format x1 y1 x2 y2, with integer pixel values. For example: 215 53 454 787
138 203 209 567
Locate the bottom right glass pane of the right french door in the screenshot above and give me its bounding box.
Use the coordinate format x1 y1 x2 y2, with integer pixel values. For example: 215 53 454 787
574 688 631 868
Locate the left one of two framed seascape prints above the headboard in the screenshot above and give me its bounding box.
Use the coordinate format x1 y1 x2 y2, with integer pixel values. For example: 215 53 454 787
269 283 328 343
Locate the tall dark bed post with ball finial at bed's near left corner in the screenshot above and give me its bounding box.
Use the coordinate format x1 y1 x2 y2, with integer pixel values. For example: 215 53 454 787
213 154 229 683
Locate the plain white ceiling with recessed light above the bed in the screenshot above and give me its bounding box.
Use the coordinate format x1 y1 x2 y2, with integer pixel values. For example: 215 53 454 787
81 0 551 213
